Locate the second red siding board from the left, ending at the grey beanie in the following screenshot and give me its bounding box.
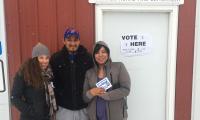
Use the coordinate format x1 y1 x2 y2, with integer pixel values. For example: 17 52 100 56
18 0 39 61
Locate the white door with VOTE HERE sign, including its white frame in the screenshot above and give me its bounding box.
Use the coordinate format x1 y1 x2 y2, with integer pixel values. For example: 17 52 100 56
96 5 177 120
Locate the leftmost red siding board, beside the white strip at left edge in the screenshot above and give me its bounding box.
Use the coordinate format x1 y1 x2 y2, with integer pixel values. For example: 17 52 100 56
5 0 21 120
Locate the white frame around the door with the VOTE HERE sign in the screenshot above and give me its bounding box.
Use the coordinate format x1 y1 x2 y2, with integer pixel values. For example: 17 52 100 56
95 4 178 120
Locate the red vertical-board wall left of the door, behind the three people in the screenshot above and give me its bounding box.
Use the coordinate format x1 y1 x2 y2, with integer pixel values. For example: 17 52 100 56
5 0 94 120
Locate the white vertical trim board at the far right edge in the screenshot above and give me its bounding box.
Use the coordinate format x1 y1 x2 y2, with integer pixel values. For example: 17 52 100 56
191 0 200 120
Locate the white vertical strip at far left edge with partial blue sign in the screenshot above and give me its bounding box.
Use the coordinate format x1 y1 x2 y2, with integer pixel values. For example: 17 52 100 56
0 0 10 120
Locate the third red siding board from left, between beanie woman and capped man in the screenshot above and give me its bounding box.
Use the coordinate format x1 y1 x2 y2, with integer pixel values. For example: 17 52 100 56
37 0 58 52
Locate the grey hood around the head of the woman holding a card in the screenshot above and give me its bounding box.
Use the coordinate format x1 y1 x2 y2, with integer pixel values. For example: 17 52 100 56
92 41 112 70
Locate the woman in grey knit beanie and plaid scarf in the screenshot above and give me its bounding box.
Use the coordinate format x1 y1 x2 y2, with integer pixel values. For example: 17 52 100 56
11 43 57 120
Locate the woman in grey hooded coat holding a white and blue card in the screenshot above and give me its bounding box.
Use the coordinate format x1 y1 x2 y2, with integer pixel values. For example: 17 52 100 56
83 41 131 120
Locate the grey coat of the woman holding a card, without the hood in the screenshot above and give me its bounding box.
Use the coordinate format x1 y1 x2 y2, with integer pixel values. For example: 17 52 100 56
83 40 131 120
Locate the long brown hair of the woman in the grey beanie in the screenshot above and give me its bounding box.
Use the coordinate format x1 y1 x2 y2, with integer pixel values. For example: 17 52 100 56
22 57 44 88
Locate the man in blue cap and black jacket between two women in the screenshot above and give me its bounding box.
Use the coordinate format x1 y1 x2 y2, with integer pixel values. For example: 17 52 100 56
50 28 93 120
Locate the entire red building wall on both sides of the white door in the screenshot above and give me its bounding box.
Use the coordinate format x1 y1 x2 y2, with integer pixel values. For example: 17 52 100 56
4 0 196 120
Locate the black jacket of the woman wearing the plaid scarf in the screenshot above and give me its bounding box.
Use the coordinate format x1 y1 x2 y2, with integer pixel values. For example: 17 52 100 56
11 71 49 120
